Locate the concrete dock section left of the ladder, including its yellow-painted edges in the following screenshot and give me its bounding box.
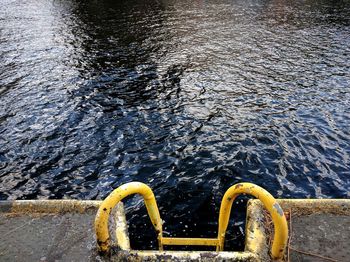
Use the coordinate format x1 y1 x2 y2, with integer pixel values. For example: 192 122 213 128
0 200 128 261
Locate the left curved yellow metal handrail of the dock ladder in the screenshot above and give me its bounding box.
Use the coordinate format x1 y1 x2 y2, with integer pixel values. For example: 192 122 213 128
95 182 162 252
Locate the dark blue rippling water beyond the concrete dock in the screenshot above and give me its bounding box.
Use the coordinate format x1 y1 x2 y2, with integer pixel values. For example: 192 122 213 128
0 0 350 248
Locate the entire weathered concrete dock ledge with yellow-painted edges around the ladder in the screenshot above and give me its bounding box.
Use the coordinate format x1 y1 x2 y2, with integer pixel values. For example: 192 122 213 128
0 199 350 261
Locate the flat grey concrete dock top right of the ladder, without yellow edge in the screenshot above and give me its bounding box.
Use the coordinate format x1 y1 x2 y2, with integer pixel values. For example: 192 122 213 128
290 213 350 261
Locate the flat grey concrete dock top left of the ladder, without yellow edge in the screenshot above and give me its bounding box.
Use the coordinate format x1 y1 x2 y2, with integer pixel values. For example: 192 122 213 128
0 213 96 262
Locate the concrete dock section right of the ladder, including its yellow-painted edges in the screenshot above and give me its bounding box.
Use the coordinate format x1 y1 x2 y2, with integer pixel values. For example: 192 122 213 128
245 199 350 261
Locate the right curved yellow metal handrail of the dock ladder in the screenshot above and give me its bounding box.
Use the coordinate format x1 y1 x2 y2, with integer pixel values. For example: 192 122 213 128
217 183 288 259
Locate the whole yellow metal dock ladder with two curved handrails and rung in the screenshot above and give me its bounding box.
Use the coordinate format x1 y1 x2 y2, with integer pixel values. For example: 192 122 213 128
95 182 288 259
